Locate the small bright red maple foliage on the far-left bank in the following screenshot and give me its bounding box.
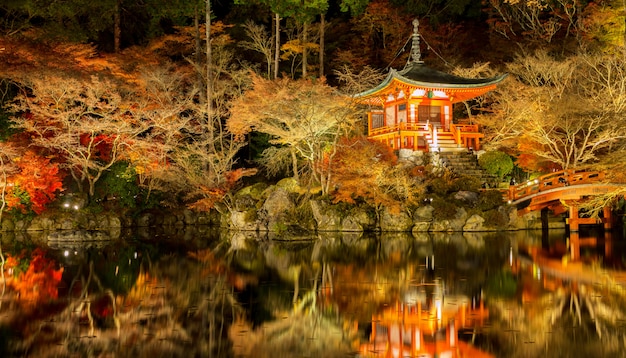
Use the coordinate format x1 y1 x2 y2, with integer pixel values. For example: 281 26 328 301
6 151 63 214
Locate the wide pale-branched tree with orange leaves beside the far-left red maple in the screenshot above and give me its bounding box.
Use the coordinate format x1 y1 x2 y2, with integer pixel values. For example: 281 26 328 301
13 75 146 196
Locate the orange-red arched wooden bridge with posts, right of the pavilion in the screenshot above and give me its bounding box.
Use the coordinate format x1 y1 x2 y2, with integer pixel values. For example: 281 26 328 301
506 169 626 231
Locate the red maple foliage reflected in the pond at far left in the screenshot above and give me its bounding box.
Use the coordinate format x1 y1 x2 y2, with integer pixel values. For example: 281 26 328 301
5 248 63 308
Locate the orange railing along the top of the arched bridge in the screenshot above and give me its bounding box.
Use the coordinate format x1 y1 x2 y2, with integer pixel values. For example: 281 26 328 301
508 169 604 201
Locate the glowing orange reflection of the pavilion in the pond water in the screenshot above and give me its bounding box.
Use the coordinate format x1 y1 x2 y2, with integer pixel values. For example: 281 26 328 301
360 280 492 358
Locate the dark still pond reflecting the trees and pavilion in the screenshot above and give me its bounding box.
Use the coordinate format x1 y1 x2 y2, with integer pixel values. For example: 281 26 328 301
0 229 626 357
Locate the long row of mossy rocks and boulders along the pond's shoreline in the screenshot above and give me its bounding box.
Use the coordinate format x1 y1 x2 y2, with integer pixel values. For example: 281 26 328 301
0 185 565 238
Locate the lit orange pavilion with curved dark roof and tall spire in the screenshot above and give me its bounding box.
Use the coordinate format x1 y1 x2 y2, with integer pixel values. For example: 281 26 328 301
356 19 506 151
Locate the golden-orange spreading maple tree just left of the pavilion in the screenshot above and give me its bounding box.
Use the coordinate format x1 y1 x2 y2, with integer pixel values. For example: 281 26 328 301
227 75 360 193
